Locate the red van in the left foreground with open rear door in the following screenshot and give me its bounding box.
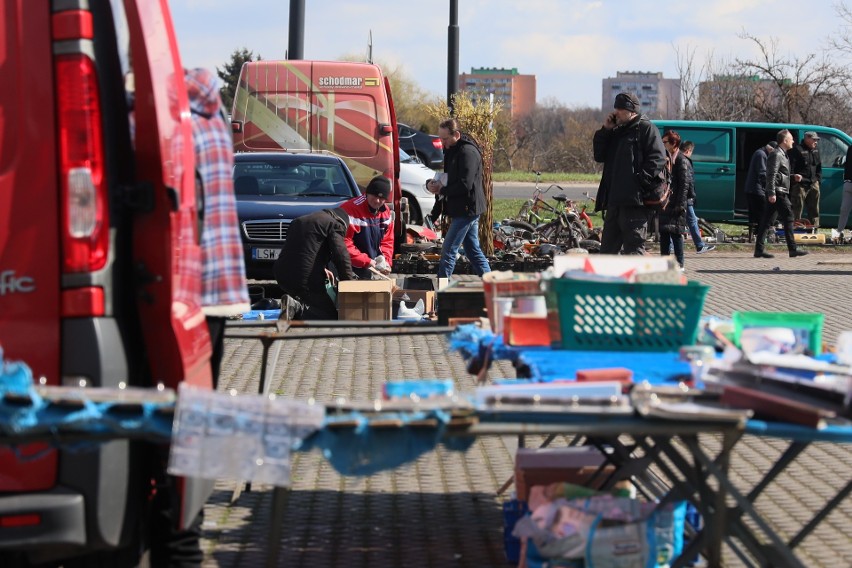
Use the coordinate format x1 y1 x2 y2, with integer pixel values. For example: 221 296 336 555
0 0 211 567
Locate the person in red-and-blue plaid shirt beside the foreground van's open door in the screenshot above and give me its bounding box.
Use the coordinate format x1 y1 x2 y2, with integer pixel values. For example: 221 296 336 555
184 69 251 388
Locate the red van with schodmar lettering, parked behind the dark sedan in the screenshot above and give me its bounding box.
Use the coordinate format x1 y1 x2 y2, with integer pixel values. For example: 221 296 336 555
231 60 405 246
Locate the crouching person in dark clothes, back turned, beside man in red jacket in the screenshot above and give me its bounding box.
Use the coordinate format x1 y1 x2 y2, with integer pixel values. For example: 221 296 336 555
273 207 355 320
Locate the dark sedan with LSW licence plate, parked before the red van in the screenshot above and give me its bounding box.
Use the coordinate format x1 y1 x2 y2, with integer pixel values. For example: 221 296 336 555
234 152 361 280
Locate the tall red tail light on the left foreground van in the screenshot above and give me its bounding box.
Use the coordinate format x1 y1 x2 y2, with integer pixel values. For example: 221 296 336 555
55 54 109 272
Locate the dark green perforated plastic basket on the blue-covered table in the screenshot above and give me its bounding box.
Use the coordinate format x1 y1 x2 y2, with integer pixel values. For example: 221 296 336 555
548 278 710 351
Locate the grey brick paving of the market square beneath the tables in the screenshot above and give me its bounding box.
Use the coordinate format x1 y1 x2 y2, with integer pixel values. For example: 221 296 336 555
204 250 852 568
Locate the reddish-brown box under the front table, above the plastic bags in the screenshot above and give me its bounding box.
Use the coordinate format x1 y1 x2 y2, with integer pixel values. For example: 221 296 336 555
515 446 606 501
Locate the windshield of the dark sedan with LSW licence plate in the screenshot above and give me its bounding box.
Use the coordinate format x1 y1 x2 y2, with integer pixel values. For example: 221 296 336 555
234 159 357 199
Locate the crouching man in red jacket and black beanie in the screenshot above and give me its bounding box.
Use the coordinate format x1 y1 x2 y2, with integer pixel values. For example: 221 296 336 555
341 176 393 280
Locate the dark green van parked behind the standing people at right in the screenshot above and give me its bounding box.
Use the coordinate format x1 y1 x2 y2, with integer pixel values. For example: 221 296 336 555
652 120 852 227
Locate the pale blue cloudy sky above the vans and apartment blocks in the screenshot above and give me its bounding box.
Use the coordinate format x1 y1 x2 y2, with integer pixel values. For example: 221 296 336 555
169 0 843 108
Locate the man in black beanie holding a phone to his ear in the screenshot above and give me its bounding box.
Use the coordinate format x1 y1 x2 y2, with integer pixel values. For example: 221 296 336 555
593 93 666 254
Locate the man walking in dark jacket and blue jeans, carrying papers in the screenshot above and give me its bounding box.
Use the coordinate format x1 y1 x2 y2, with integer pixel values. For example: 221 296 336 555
426 118 491 278
